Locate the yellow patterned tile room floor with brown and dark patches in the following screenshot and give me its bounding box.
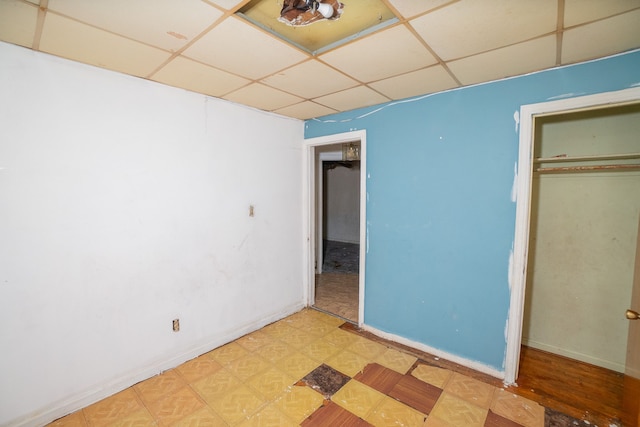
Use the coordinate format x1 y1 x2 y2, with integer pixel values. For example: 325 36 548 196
50 309 556 427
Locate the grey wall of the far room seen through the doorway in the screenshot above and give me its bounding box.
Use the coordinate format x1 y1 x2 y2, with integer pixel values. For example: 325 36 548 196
325 162 360 243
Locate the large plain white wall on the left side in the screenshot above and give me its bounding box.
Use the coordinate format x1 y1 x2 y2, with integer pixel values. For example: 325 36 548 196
0 43 303 425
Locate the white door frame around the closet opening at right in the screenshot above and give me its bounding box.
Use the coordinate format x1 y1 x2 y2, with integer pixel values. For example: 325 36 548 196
504 87 640 384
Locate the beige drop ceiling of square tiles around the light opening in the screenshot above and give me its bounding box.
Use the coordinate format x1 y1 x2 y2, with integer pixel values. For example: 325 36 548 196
0 0 640 119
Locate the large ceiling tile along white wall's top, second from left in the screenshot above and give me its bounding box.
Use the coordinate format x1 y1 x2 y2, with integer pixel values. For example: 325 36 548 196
40 12 169 77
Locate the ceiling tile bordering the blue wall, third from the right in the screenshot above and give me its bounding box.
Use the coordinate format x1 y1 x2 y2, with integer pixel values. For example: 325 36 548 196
369 65 458 99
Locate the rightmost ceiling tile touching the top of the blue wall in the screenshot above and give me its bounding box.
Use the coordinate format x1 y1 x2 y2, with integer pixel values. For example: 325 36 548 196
562 10 640 64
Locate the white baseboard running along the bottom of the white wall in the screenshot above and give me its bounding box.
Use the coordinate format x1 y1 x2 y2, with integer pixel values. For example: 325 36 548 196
5 303 305 427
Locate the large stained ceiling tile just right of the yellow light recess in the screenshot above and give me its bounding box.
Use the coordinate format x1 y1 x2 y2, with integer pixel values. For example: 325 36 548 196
410 0 558 61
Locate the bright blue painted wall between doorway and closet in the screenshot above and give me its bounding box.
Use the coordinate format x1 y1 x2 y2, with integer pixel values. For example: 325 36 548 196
305 51 640 371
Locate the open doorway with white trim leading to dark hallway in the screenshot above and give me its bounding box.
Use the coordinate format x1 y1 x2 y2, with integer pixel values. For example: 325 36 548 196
305 131 366 326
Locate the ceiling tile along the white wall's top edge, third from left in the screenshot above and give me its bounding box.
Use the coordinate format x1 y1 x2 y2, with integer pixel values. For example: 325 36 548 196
151 57 251 97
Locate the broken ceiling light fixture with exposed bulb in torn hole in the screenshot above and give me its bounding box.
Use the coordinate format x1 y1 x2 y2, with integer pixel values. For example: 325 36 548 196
278 0 344 27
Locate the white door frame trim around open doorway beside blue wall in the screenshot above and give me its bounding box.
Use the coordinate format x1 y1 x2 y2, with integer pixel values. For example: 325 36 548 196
302 130 368 326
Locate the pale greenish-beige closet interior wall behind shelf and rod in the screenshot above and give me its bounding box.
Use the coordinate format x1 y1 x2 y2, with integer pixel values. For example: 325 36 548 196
523 107 640 372
